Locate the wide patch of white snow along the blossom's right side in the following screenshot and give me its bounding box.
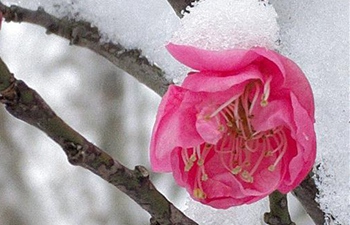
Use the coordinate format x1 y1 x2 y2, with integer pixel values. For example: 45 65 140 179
273 0 350 225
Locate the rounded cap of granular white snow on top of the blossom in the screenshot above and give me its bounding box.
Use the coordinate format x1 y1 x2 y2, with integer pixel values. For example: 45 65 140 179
171 0 279 50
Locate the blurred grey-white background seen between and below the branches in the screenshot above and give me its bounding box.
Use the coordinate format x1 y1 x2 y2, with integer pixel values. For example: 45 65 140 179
0 23 312 225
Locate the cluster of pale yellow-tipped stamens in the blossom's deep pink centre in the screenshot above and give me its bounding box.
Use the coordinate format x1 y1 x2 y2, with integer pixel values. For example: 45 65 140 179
182 78 287 199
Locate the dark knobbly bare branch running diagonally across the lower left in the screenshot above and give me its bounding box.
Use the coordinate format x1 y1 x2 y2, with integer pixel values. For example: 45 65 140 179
0 58 196 225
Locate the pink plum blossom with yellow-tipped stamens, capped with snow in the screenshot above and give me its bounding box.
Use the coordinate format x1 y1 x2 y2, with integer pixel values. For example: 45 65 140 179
150 44 316 208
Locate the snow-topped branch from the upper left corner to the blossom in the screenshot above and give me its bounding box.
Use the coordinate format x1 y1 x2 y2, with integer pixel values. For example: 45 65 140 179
0 2 172 96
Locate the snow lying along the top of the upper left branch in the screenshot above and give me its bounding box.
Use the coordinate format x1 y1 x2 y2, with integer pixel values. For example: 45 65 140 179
2 0 188 80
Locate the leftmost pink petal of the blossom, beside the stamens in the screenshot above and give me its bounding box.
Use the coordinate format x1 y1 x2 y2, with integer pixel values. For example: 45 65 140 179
150 85 202 172
